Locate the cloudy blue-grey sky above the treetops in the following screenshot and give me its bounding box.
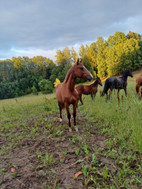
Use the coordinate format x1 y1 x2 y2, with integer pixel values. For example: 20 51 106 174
0 0 142 61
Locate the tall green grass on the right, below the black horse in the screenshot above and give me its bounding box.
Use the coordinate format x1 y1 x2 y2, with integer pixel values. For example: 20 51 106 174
79 80 142 153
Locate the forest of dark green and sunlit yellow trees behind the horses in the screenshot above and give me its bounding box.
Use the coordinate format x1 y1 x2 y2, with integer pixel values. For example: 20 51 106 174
0 31 142 99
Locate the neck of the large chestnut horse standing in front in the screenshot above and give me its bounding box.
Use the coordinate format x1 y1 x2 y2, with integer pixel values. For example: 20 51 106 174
64 72 76 91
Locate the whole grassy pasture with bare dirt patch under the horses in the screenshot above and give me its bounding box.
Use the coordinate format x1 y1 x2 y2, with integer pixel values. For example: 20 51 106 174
0 73 142 189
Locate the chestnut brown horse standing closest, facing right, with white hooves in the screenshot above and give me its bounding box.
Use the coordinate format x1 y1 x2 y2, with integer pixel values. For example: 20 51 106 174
56 59 93 131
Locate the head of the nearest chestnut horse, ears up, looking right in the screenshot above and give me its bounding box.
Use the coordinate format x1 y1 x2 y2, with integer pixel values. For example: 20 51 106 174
73 59 93 81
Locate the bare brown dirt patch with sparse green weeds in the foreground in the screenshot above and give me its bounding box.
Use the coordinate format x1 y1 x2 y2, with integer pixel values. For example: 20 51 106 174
0 114 141 189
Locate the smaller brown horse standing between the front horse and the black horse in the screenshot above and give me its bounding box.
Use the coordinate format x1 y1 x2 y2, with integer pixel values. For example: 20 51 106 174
75 78 102 104
